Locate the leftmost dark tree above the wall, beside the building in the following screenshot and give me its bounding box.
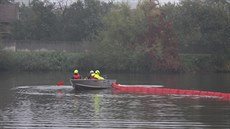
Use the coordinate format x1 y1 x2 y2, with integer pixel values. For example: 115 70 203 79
14 0 56 40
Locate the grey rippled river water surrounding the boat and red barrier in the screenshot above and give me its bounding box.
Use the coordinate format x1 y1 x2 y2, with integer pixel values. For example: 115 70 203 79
0 72 230 129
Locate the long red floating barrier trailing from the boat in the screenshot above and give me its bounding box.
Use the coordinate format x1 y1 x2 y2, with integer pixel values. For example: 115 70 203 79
112 83 230 101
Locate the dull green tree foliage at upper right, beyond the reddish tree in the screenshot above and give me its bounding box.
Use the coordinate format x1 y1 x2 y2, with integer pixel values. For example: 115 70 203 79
162 0 230 54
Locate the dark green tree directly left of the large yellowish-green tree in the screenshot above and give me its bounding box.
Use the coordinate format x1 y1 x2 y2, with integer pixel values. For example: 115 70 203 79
61 0 111 41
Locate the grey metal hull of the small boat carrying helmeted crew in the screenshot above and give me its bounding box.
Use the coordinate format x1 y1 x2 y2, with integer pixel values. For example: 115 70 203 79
70 79 116 90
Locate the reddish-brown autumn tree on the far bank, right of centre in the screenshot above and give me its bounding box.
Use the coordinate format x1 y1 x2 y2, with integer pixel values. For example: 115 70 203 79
138 0 180 71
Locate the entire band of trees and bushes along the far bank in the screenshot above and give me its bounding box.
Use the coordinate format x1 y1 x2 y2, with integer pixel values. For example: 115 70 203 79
0 0 230 72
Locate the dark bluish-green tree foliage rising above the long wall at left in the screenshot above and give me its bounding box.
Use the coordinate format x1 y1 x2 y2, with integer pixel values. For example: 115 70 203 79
14 0 112 41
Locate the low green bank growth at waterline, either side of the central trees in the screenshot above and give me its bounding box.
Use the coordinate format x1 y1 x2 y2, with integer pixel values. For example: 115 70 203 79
0 51 230 72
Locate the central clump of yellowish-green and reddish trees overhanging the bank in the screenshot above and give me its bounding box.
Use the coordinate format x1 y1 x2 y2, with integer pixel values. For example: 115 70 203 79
86 1 180 72
